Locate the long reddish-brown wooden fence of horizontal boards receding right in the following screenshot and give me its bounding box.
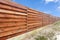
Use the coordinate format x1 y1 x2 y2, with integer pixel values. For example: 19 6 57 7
0 0 58 40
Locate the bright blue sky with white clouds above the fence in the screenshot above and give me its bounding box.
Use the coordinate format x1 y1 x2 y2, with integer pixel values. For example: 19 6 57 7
13 0 60 17
